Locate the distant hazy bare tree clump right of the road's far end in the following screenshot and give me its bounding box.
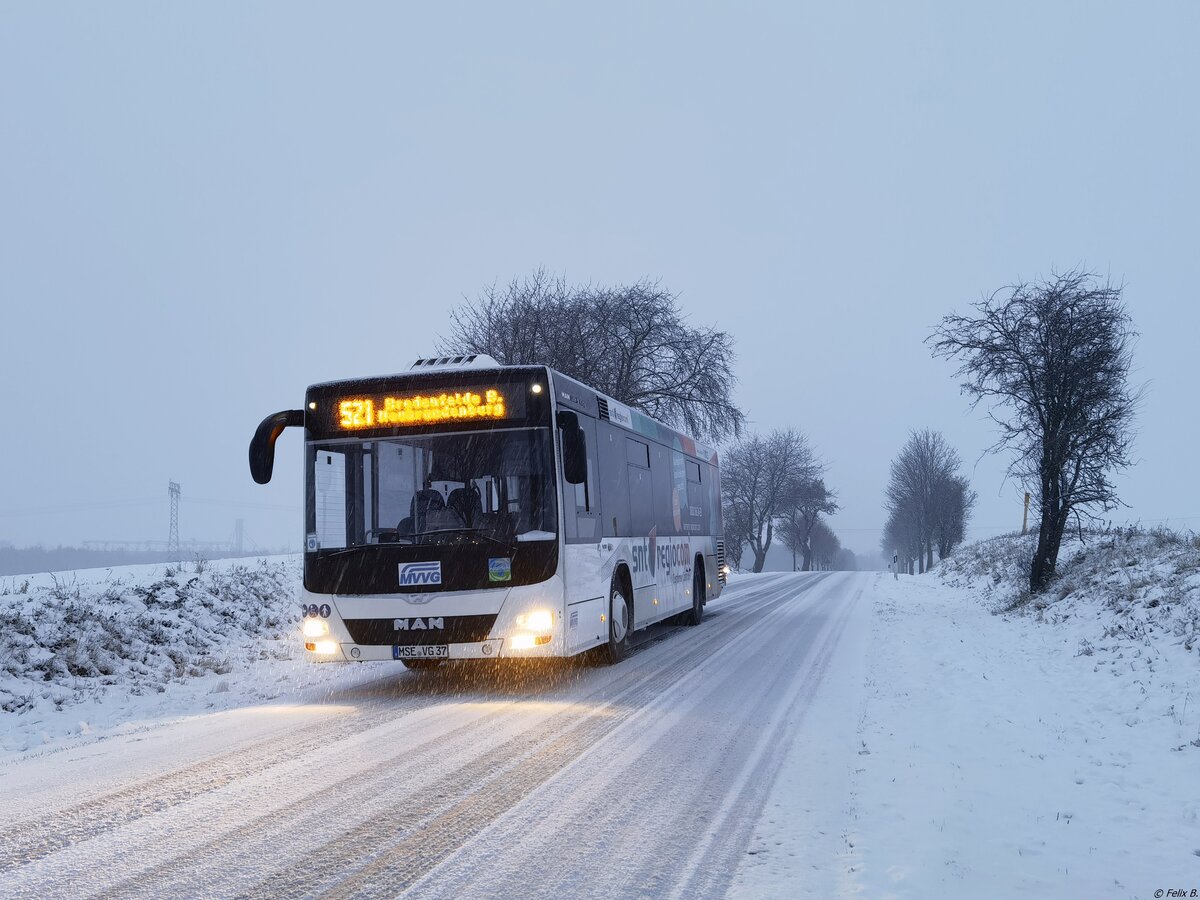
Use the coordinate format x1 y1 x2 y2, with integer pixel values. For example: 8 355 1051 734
882 428 976 572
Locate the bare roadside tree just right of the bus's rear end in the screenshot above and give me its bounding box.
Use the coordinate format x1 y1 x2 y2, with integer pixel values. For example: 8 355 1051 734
721 428 818 572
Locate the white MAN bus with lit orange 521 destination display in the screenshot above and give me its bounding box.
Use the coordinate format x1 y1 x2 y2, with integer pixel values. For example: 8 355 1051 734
250 355 728 670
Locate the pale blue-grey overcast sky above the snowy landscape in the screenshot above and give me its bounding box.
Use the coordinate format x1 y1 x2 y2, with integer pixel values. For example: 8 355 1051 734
0 2 1200 561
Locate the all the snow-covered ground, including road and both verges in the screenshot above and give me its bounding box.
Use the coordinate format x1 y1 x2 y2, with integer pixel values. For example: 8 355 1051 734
0 542 1200 899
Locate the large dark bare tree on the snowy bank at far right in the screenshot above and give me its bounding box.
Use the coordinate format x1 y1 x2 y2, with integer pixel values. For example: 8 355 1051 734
929 269 1141 593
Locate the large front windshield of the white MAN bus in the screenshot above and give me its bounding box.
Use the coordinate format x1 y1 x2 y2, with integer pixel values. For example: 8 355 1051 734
306 428 558 551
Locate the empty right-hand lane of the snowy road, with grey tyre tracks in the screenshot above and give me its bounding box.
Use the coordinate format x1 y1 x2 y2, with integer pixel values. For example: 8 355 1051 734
405 573 864 898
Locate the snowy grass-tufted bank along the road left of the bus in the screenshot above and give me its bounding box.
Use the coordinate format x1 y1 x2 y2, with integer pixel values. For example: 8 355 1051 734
0 557 378 752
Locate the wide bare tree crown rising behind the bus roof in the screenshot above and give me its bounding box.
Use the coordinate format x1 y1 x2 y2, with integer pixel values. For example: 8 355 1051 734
439 269 745 442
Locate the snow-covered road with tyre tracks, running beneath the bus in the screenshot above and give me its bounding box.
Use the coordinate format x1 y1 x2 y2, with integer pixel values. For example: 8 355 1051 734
0 574 877 898
